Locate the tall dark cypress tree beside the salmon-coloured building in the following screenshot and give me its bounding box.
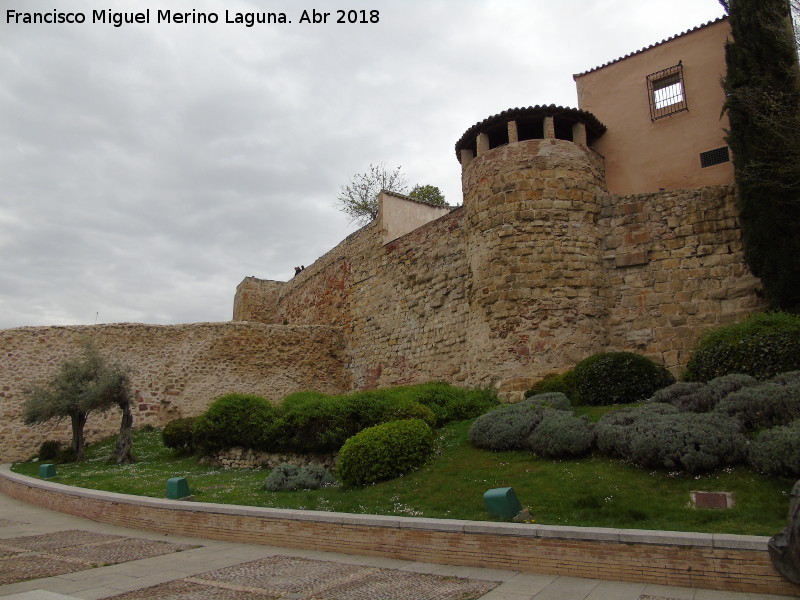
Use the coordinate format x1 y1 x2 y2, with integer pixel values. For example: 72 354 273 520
721 0 800 312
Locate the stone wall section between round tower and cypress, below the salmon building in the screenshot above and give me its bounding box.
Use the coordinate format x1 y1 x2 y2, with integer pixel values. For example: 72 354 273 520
598 185 766 375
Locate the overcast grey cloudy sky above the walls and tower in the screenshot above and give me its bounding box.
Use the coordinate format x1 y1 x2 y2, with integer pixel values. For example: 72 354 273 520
0 0 722 329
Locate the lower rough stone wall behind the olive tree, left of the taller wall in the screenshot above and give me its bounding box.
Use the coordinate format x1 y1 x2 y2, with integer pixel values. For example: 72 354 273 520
0 323 350 462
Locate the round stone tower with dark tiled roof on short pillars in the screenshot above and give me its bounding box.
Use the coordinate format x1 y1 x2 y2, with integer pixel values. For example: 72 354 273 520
456 106 607 398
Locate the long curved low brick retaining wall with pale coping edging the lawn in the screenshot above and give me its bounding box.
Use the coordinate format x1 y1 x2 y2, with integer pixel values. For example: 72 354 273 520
0 465 800 596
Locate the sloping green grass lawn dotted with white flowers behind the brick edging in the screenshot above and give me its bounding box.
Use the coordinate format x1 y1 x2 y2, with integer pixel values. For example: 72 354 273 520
13 422 793 536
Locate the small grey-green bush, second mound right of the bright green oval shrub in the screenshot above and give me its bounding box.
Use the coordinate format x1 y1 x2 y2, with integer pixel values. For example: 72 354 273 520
528 409 594 458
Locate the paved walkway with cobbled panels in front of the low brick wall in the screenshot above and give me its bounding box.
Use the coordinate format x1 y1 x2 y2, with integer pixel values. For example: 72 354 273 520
0 494 786 600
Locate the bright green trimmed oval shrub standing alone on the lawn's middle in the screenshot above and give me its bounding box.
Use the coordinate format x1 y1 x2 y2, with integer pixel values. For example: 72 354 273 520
337 419 433 486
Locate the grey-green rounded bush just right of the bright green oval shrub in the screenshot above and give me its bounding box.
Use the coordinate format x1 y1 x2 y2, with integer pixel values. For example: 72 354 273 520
469 400 544 450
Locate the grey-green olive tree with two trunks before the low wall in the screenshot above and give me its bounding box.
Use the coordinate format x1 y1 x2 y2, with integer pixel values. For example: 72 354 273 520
23 342 135 464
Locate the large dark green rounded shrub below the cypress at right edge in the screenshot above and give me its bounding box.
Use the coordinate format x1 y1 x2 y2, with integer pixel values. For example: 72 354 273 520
685 312 800 381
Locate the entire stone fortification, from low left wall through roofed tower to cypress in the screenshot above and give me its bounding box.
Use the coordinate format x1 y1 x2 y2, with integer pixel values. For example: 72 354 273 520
0 107 764 460
